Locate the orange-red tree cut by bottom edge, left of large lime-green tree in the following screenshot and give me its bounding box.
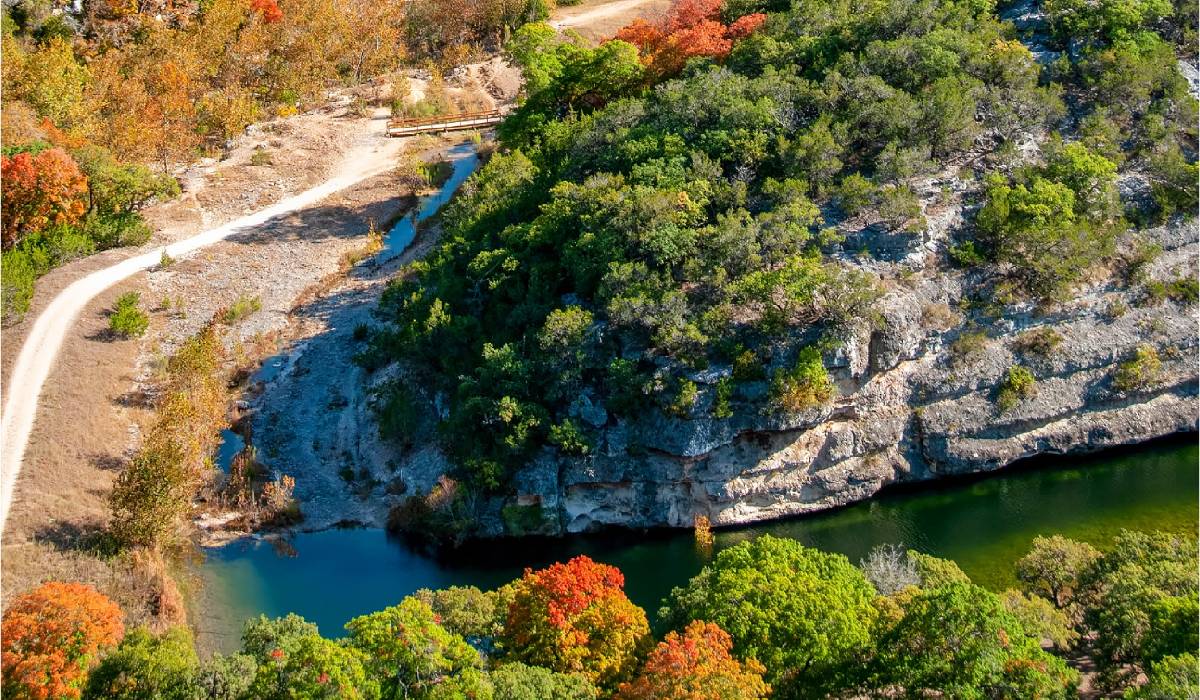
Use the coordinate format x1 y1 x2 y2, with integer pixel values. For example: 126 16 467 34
616 620 770 700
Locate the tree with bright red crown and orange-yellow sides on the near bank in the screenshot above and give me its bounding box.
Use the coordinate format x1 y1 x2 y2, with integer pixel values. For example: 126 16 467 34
503 556 649 688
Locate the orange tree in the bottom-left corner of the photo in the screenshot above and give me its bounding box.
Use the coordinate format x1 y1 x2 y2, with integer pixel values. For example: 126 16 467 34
0 582 125 700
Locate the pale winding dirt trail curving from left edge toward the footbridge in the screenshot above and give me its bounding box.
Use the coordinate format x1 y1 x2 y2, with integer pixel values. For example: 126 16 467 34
0 136 403 532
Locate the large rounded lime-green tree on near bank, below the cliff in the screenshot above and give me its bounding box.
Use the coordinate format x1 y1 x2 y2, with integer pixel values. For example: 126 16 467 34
660 536 875 696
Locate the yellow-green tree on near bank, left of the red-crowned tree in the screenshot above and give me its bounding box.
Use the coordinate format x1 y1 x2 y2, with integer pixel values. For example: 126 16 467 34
346 597 482 698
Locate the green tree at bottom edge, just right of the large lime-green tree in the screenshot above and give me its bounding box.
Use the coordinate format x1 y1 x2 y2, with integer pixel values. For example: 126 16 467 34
871 584 1079 700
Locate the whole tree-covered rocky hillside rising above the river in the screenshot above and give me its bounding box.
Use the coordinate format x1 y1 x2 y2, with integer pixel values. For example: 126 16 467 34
359 0 1198 536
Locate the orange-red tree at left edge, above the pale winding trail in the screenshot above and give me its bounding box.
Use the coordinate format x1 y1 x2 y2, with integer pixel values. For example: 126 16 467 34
0 148 88 250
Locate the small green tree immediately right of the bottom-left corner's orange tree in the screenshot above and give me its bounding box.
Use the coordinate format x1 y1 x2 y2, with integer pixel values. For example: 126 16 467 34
83 626 200 700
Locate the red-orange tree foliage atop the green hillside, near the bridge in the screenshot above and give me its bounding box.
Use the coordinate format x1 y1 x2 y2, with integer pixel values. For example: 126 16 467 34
616 0 767 79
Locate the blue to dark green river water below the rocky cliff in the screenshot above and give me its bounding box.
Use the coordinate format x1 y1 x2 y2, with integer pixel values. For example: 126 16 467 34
200 436 1200 648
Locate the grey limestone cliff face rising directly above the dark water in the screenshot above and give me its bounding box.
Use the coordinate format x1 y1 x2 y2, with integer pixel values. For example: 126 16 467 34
489 221 1200 534
